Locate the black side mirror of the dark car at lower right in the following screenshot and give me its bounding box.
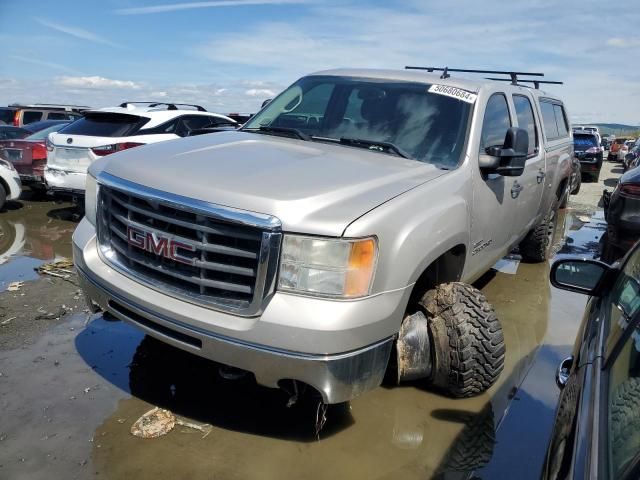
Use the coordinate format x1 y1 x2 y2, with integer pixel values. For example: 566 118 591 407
549 258 611 297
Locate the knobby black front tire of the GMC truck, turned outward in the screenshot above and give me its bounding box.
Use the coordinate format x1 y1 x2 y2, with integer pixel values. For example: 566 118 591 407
418 282 505 398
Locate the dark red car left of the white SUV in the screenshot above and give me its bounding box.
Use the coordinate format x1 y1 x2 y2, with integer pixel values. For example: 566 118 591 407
0 120 70 190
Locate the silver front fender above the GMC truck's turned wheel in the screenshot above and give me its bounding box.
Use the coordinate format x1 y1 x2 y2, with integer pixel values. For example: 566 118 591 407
344 169 470 293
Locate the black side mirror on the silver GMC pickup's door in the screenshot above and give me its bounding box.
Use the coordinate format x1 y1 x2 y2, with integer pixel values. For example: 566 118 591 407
480 127 529 177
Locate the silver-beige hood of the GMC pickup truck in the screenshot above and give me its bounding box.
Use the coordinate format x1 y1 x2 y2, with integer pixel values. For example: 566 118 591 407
101 132 446 236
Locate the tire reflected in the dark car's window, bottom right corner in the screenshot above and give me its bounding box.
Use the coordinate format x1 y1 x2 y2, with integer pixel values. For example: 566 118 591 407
611 377 640 466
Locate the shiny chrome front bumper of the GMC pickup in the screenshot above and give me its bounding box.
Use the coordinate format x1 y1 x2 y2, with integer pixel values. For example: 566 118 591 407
78 269 393 403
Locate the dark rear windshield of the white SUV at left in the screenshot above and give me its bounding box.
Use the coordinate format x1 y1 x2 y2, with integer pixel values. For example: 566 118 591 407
60 113 149 137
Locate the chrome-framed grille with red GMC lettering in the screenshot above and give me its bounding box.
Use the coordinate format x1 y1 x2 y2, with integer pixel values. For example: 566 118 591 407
98 175 280 315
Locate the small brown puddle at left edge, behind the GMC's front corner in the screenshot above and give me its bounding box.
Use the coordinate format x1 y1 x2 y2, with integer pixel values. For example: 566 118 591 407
0 201 77 292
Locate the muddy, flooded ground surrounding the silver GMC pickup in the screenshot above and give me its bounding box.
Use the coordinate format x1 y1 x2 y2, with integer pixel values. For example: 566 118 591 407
0 162 621 479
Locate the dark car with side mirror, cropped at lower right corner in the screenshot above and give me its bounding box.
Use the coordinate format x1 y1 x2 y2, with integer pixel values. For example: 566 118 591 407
543 242 640 480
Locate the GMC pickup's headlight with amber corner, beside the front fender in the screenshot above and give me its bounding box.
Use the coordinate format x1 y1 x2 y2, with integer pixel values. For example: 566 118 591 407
278 235 378 298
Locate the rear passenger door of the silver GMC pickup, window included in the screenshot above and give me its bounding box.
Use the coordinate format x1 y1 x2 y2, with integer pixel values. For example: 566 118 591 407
510 93 546 243
